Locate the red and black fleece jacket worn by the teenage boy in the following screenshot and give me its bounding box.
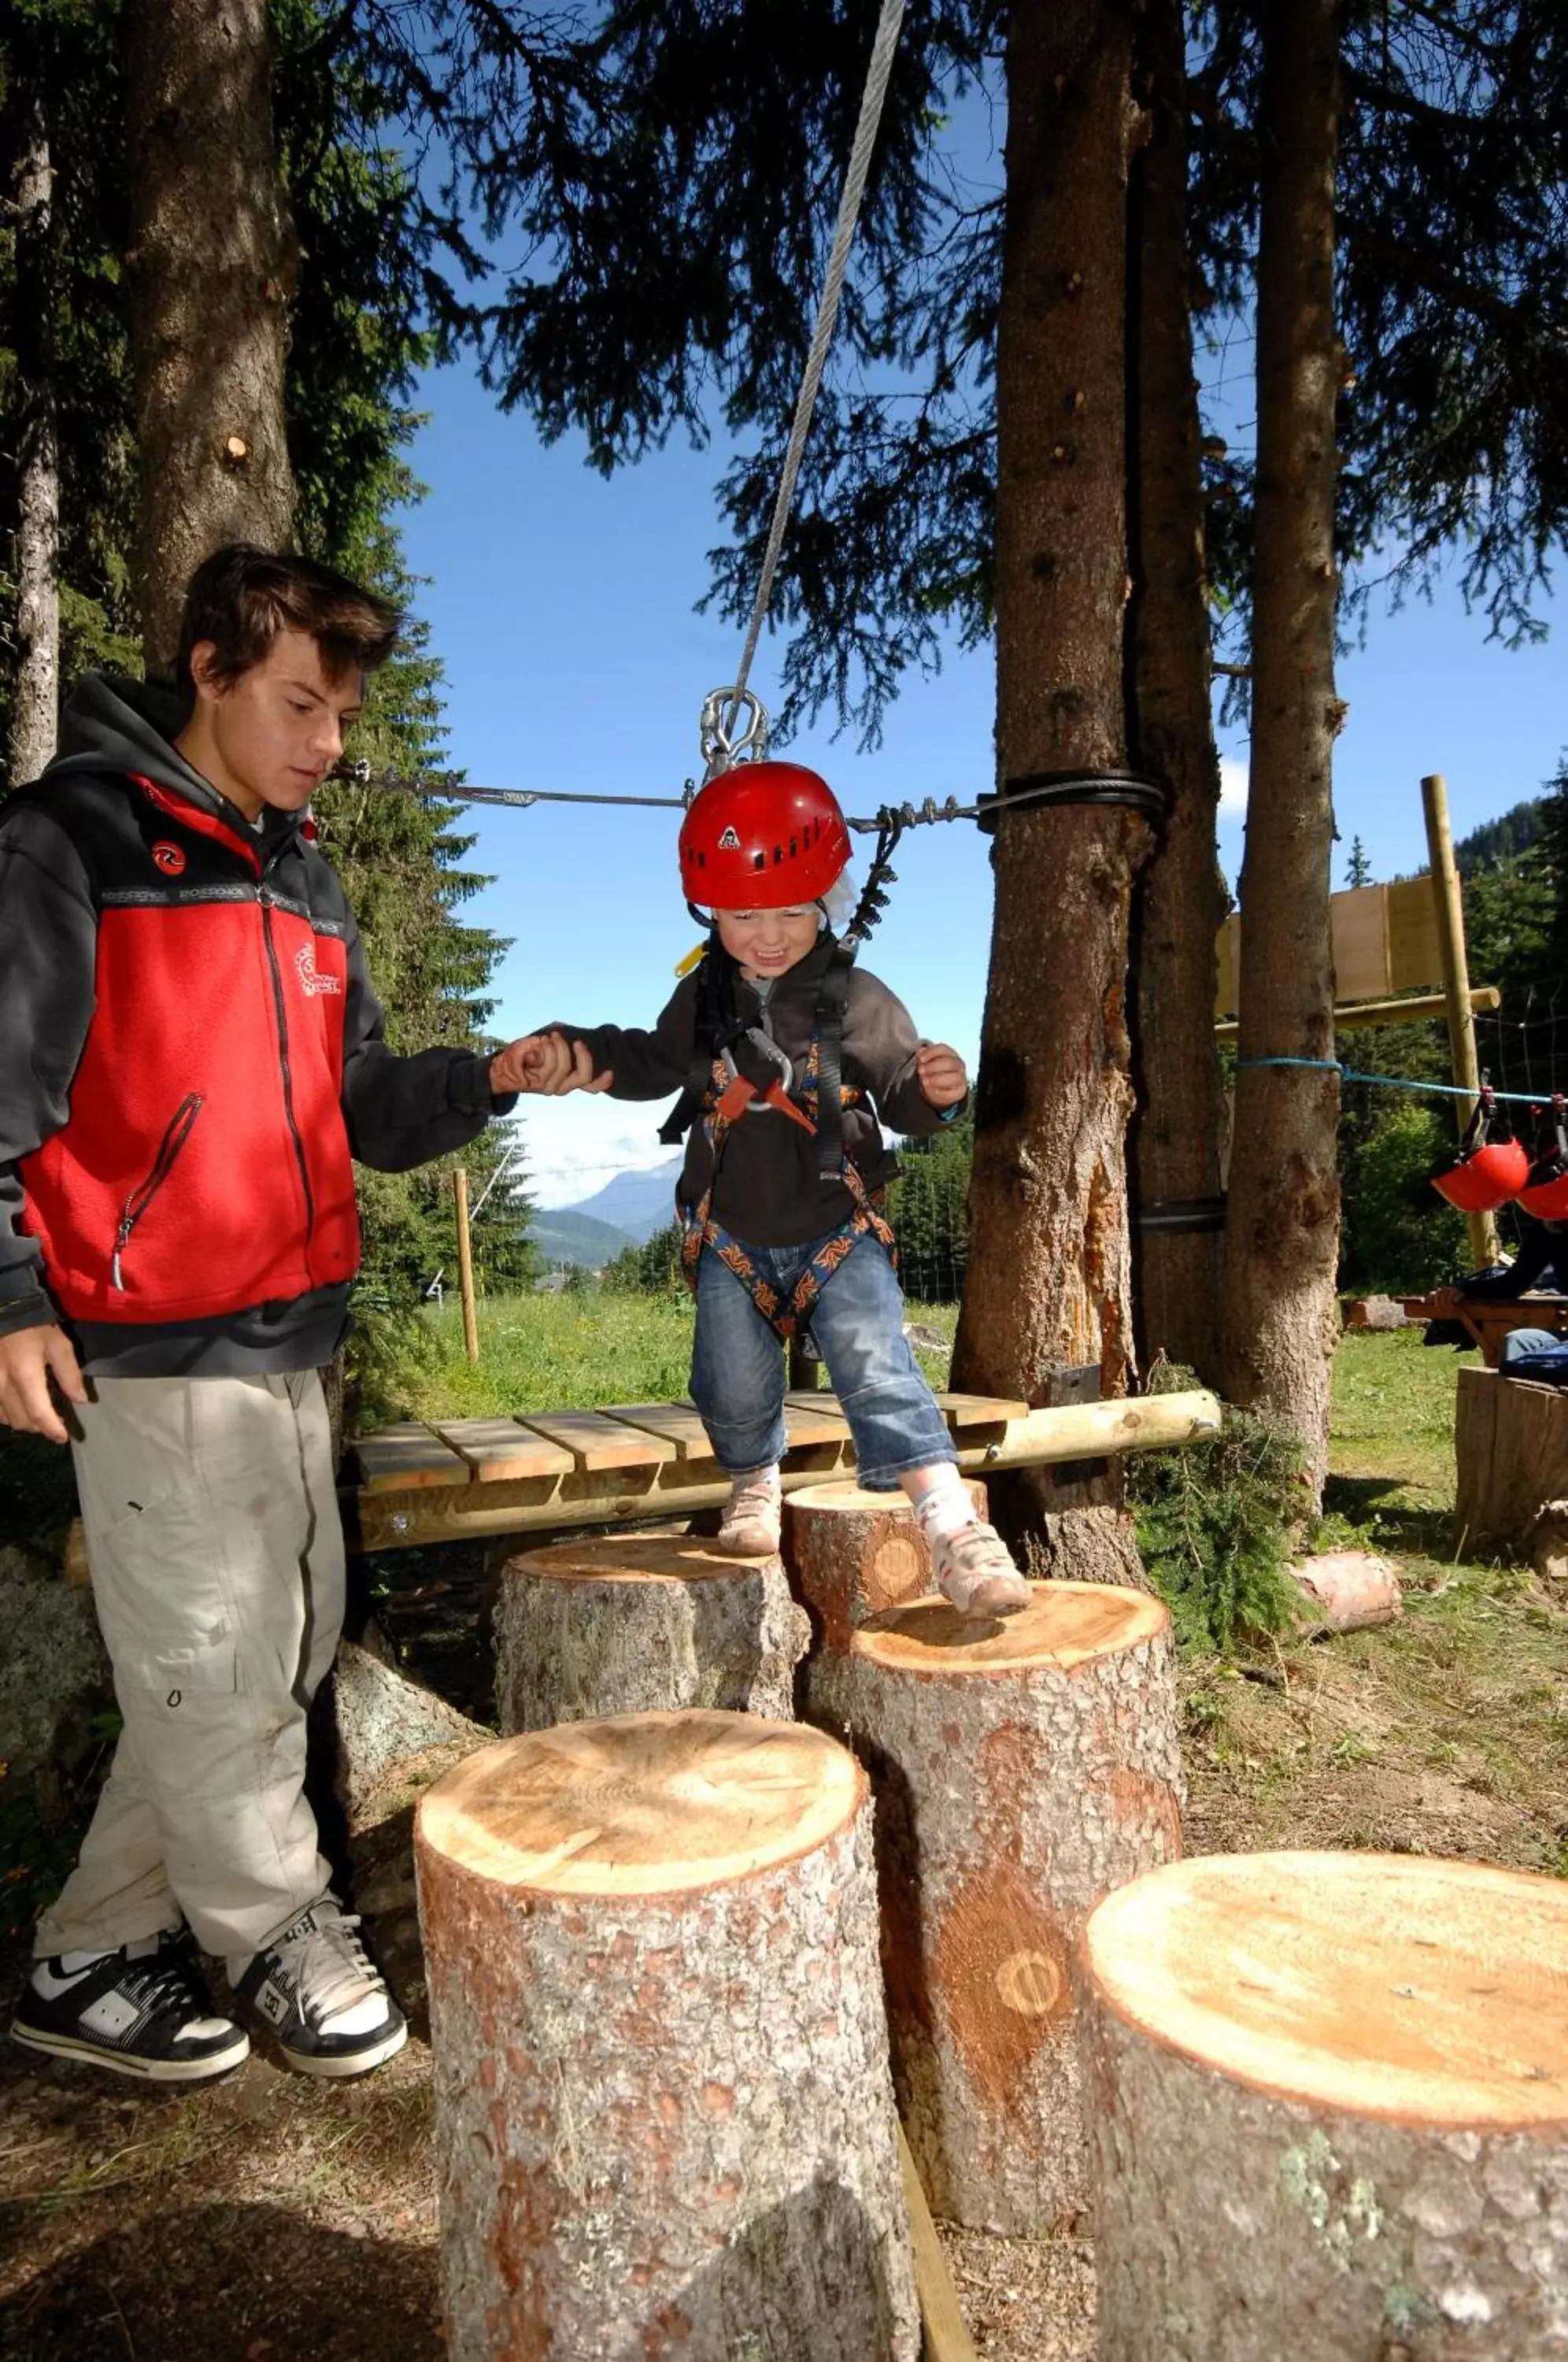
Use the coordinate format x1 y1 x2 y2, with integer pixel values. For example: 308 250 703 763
0 676 505 1375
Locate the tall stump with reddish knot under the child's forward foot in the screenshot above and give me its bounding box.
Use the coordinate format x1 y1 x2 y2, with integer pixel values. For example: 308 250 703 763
810 1583 1181 2237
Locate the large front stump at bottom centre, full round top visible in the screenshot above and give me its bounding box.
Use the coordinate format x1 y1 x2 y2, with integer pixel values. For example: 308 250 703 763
416 1712 919 2362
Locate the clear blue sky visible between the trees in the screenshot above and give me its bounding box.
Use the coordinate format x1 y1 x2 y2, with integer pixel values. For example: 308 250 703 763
404 350 1568 1205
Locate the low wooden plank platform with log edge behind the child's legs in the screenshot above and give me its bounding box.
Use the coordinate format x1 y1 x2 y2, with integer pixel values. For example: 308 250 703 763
349 1391 1219 1549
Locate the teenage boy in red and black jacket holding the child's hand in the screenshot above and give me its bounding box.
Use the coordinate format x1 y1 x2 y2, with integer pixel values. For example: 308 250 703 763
0 546 534 2081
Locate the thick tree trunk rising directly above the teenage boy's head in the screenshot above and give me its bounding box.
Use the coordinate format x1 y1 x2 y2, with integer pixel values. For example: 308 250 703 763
125 0 295 673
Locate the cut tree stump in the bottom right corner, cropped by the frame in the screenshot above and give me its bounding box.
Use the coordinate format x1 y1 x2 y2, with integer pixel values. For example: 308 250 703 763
1084 1854 1568 2362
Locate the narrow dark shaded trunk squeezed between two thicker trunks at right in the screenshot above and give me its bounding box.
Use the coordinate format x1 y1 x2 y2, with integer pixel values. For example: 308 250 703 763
1131 0 1223 1384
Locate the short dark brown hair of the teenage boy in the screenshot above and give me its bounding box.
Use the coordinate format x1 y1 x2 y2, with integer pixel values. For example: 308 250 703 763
175 541 404 694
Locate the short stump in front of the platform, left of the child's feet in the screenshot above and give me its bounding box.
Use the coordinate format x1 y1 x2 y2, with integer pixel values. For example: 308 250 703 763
494 1533 810 1731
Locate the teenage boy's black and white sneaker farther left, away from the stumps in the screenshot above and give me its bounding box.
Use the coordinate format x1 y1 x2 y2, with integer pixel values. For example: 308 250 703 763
12 1934 250 2083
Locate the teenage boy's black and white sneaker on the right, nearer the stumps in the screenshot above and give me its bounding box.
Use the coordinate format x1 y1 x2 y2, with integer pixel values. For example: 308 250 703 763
234 1894 409 2074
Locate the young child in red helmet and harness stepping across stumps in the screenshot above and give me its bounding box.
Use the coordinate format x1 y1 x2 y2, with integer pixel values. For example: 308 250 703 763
508 763 1030 1616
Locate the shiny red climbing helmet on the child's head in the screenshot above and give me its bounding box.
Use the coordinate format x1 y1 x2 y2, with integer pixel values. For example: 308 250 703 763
680 763 850 909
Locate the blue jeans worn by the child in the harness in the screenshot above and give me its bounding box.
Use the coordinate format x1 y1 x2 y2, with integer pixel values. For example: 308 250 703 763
692 1231 956 1493
